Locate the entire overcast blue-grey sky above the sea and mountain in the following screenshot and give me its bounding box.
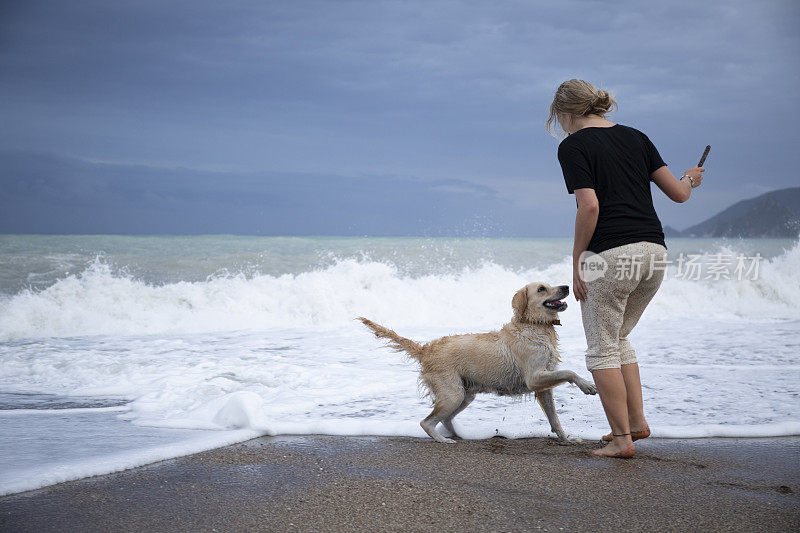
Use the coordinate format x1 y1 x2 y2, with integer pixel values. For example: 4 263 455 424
0 0 800 237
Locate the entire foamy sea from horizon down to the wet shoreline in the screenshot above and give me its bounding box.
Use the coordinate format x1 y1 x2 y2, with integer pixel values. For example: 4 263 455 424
0 235 800 494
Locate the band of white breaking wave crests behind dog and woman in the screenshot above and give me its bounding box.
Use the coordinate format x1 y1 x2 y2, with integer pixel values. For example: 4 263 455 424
0 238 800 340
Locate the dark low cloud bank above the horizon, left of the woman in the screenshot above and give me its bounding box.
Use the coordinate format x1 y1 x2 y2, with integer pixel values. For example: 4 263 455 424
0 152 572 236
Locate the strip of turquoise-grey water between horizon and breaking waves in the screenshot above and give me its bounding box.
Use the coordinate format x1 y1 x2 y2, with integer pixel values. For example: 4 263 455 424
0 235 794 295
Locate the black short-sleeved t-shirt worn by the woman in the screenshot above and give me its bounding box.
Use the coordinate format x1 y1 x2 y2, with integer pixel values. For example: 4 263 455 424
558 124 666 253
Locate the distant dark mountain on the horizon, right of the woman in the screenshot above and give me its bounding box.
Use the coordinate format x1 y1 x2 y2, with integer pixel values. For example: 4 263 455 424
664 187 800 238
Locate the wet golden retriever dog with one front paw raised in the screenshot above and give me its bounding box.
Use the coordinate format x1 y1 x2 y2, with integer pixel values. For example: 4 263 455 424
358 283 597 442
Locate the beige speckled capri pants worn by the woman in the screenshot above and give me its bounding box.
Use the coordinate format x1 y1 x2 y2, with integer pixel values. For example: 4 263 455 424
581 241 667 371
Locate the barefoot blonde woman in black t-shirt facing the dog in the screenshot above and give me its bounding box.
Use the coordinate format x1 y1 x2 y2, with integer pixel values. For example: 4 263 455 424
546 79 705 457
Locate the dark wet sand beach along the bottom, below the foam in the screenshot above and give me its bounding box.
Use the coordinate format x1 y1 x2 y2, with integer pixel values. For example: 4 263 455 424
0 436 800 531
